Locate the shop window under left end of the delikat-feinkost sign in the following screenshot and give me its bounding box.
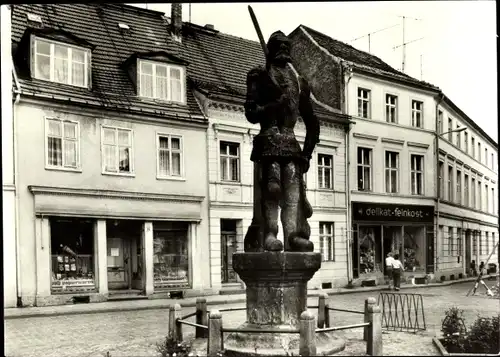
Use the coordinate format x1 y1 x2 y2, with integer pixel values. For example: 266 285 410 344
358 226 382 274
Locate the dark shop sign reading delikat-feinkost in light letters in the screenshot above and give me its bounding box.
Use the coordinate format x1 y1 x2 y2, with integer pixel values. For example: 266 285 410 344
352 202 434 223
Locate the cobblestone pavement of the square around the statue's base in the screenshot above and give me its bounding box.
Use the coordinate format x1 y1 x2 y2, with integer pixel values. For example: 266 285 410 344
4 282 499 357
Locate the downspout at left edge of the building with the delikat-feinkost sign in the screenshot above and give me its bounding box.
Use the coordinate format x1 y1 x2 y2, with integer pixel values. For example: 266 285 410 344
344 66 353 287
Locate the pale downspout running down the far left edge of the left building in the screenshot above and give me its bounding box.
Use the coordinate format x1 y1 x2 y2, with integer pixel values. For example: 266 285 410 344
10 57 23 307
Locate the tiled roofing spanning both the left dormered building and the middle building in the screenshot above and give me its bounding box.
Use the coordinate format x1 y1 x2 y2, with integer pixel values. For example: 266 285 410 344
12 3 348 124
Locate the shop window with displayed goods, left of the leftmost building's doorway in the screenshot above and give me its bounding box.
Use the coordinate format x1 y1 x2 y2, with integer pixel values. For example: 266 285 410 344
50 218 95 293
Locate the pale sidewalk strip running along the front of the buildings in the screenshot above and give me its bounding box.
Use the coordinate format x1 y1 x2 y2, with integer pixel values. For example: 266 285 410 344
4 276 488 319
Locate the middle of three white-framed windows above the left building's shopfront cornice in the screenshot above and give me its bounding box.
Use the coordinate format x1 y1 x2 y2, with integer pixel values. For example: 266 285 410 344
102 127 133 174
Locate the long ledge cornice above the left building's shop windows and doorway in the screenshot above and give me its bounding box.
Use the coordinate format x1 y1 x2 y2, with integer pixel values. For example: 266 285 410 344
28 185 205 202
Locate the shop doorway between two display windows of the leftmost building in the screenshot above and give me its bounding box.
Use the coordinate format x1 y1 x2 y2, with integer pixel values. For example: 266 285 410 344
106 220 144 291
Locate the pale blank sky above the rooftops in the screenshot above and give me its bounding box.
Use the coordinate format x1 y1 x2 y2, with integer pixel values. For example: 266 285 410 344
134 0 498 142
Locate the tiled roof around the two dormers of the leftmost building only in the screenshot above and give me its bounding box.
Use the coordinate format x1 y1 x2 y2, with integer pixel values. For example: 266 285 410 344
12 3 204 121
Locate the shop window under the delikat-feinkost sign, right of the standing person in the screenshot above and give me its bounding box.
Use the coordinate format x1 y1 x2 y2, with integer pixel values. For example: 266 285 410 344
403 226 426 271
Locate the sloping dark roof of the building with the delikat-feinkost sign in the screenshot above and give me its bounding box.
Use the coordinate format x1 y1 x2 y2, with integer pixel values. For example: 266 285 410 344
293 25 439 90
